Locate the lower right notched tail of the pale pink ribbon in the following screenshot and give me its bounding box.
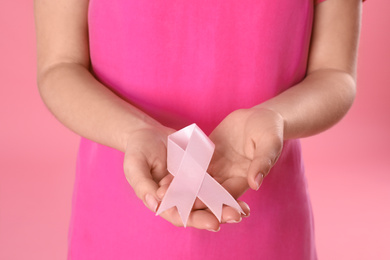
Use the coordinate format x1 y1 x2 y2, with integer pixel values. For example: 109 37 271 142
198 173 245 222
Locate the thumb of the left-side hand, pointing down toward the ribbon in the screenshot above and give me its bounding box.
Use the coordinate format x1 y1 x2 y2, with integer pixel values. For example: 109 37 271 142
123 154 159 212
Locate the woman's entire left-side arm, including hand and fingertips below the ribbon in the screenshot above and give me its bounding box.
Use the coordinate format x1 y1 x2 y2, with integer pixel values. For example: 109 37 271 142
34 0 247 230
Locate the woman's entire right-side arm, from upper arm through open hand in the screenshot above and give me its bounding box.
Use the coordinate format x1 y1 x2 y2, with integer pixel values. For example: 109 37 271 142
209 0 361 192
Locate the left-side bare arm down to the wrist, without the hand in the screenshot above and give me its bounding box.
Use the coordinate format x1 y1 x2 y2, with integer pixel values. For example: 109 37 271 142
35 0 158 152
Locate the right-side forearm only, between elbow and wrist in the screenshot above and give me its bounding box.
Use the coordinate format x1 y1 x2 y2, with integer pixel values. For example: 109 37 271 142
257 69 356 140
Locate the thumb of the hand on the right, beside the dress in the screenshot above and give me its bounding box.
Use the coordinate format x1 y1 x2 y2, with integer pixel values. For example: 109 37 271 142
247 139 283 190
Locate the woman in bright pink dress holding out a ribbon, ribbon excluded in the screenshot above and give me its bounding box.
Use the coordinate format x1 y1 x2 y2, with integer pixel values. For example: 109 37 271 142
35 0 361 259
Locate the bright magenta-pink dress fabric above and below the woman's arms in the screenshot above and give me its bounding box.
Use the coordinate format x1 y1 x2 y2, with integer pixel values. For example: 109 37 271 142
68 0 317 260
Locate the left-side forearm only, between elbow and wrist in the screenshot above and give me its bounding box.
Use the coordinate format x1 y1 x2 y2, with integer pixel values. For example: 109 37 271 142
38 63 158 151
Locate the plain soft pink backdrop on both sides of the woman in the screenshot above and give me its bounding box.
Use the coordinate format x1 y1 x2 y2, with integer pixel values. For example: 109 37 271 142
0 0 390 260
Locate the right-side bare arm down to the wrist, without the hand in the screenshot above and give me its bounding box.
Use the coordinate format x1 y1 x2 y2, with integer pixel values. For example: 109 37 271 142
259 0 361 139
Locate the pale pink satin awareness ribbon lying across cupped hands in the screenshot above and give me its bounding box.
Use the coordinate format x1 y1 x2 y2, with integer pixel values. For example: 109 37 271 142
156 124 244 226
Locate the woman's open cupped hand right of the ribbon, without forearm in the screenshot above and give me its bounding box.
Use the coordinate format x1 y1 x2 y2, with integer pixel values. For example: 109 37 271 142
209 107 284 198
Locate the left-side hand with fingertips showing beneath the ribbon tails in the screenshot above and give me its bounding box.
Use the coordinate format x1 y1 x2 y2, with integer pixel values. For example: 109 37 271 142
124 125 245 231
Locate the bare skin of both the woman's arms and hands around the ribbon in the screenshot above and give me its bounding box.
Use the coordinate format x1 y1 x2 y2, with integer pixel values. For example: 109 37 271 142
35 0 361 231
